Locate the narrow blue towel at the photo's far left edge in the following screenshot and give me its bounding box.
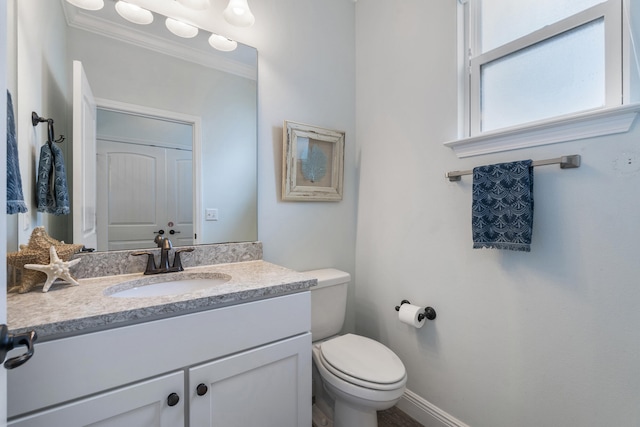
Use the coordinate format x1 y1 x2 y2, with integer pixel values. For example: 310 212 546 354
7 91 28 215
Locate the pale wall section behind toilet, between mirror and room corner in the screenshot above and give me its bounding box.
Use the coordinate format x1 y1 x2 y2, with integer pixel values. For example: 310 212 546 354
239 0 358 328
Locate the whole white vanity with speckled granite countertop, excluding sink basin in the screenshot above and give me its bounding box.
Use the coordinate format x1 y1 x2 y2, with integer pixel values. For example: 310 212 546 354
7 246 317 427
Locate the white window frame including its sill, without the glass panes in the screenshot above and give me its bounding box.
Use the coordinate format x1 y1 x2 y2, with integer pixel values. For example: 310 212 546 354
445 0 640 157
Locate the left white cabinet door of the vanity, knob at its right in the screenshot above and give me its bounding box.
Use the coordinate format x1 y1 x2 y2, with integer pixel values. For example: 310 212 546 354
9 371 185 427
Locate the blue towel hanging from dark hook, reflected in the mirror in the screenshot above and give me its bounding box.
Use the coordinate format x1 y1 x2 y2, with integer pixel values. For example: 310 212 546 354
36 141 70 215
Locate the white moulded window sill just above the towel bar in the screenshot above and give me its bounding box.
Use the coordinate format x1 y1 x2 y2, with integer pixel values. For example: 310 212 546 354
444 103 640 158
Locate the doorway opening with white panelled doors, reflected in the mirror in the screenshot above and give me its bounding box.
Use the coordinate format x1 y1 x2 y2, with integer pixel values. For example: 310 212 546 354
96 108 194 251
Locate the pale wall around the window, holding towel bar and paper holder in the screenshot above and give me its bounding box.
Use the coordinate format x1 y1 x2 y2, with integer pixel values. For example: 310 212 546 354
356 0 640 427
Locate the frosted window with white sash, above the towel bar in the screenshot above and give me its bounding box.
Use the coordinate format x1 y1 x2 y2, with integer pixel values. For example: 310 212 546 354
446 0 640 157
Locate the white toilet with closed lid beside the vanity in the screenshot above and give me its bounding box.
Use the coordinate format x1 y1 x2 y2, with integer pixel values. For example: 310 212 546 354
306 268 407 427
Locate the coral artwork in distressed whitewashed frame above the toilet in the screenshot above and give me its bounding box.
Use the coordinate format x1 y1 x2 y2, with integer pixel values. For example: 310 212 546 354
282 121 345 202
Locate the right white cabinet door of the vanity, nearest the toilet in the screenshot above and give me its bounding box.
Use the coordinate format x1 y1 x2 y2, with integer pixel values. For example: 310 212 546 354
189 333 311 427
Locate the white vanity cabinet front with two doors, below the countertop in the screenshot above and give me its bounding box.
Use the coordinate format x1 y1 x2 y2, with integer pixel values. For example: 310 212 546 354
7 291 311 427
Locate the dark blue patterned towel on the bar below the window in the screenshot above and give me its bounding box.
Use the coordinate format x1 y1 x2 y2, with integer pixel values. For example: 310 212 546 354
471 160 533 252
